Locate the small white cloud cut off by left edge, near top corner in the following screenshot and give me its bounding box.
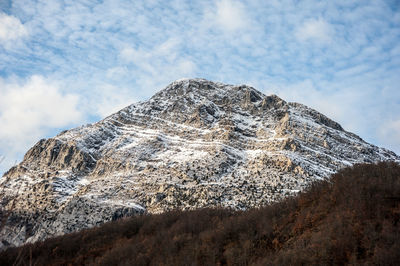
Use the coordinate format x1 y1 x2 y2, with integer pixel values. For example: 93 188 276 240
0 13 28 46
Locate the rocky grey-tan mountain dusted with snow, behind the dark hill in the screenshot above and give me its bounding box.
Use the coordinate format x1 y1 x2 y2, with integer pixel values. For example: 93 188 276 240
0 79 400 249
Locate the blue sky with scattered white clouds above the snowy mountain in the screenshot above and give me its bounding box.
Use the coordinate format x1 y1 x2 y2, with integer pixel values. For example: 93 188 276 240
0 0 400 175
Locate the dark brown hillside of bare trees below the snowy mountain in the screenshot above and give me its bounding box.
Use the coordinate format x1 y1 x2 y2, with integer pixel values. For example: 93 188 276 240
0 162 400 265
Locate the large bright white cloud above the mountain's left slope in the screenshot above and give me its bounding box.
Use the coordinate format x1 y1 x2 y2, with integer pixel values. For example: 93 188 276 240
0 76 82 174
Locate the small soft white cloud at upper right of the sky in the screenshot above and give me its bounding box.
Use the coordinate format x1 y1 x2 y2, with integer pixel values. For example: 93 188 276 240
295 18 334 43
